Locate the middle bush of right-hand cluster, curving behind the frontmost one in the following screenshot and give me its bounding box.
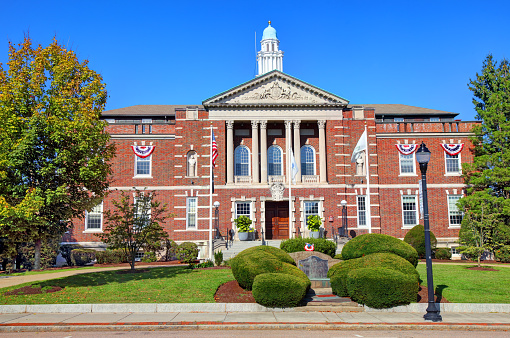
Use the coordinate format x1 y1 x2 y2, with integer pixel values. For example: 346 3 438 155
328 252 420 297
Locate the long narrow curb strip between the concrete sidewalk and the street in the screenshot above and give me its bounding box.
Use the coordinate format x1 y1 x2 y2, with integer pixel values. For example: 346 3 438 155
0 322 510 333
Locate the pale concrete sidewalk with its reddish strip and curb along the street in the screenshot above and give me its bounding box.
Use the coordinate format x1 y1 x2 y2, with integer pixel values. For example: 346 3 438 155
0 311 510 332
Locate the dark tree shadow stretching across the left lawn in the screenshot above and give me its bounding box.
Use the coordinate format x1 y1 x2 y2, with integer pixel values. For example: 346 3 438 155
34 267 193 287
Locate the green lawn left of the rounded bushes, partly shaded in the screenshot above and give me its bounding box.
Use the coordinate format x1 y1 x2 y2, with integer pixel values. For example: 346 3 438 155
0 267 234 304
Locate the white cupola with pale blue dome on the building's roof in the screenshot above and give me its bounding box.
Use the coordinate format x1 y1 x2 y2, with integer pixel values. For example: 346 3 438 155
257 21 283 75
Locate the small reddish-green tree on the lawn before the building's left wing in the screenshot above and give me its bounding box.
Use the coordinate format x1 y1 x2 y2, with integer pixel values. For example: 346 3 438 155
96 189 171 271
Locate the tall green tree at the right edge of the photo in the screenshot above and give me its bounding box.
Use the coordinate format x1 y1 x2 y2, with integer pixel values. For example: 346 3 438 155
459 55 510 254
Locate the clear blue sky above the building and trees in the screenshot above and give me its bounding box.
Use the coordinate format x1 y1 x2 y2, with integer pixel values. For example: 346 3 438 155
0 0 510 120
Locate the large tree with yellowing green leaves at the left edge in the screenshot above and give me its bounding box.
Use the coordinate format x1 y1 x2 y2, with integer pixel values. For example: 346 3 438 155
0 37 115 269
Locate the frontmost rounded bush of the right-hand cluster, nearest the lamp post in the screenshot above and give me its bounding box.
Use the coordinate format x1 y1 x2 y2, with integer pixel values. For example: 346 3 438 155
347 267 419 309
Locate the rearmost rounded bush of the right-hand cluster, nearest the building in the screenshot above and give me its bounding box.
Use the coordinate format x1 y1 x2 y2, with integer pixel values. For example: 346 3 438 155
342 234 418 267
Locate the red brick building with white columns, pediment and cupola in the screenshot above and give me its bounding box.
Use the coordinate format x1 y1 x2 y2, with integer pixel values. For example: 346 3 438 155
64 26 476 257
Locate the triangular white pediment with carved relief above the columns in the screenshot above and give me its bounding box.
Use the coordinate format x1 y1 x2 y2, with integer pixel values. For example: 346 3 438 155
203 71 349 106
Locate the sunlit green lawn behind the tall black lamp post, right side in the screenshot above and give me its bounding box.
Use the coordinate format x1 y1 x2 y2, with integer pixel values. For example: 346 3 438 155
417 263 510 303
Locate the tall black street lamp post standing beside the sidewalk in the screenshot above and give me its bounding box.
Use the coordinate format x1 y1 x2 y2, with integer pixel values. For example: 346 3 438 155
416 142 443 322
